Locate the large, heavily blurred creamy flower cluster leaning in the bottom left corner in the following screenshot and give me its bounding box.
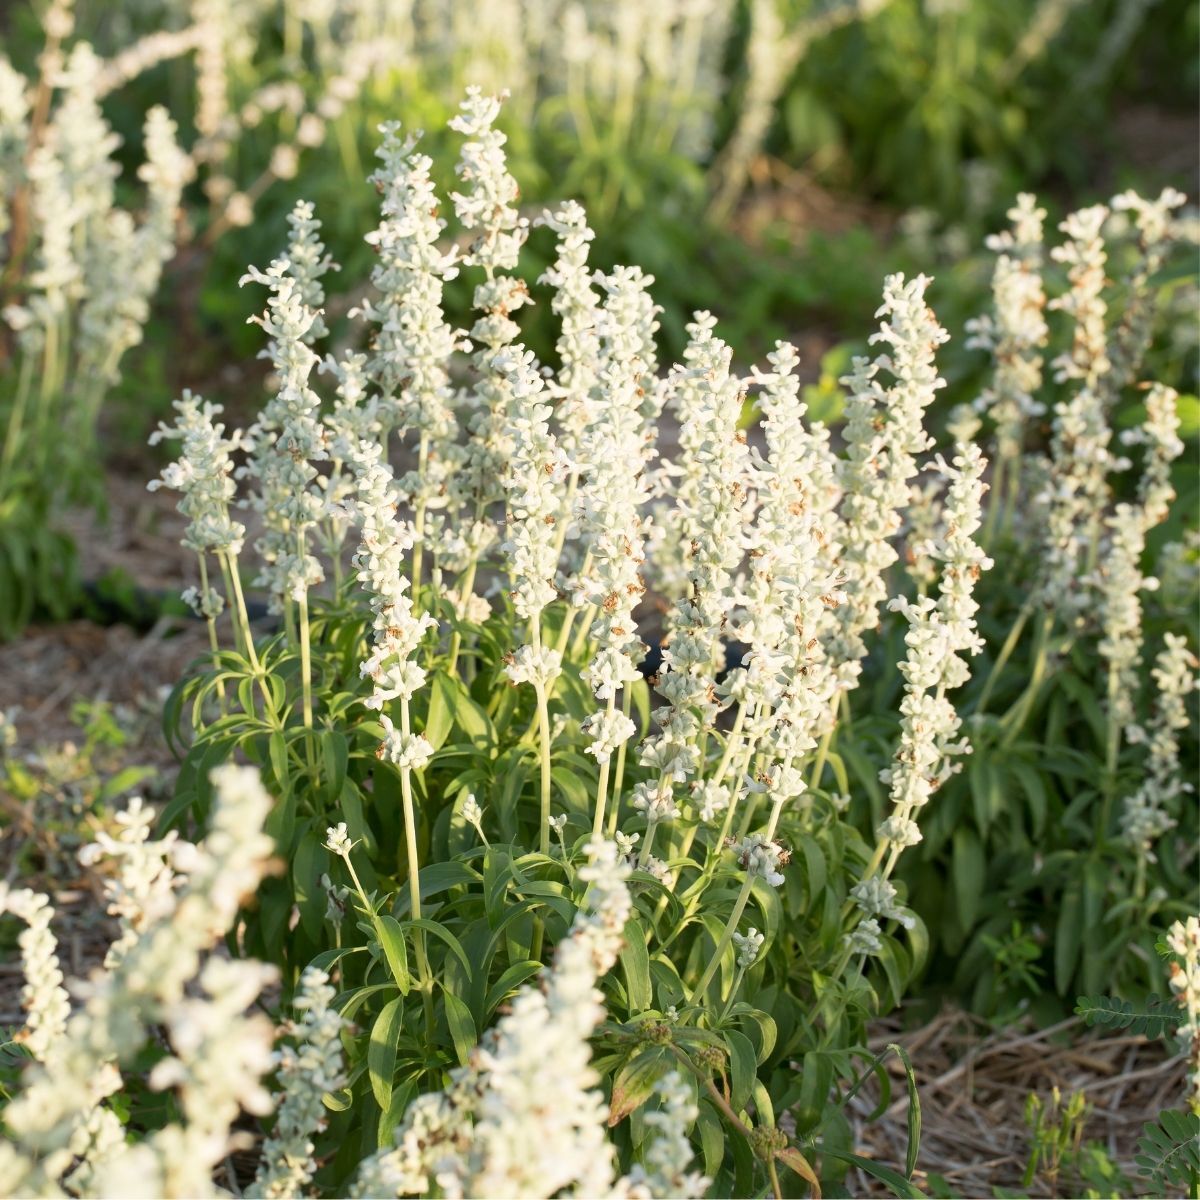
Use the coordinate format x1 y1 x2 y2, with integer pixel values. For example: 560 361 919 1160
0 766 274 1196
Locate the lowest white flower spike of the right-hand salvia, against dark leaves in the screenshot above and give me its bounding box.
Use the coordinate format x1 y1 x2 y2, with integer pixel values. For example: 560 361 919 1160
1121 634 1200 862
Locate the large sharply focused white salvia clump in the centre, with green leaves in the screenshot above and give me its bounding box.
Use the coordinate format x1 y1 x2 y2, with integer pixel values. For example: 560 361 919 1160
124 90 990 1194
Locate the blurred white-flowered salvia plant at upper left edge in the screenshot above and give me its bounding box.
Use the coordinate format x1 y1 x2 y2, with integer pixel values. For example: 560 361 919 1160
0 0 191 637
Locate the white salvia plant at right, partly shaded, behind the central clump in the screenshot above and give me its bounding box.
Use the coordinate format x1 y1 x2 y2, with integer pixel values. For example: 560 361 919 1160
873 190 1200 1007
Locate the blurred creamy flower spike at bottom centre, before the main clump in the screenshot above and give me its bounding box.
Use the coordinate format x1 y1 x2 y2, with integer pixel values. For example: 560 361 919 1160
354 841 631 1196
